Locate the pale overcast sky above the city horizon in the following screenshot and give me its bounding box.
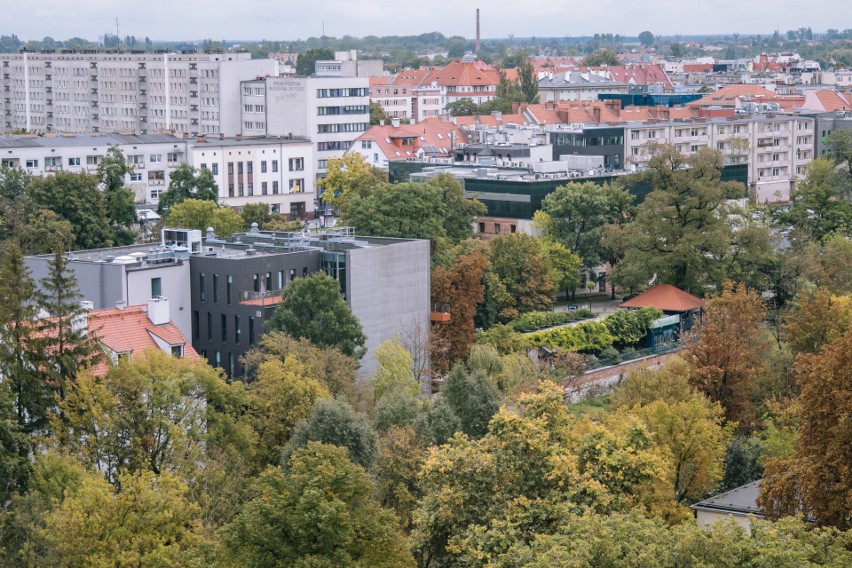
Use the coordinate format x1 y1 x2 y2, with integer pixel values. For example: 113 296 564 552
0 0 852 41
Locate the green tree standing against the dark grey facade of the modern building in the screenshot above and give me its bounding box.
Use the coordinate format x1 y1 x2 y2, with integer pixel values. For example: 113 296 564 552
266 272 366 359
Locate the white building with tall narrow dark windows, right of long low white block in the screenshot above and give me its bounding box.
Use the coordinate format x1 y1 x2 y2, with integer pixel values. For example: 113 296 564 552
188 137 316 219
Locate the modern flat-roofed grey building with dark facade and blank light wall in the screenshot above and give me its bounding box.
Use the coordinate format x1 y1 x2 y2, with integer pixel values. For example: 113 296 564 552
26 226 430 377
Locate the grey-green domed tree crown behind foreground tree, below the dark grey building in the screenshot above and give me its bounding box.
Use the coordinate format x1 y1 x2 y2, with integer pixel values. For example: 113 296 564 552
281 399 376 469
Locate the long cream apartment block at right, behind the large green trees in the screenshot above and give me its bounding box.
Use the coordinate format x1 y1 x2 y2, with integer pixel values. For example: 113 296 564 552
624 114 815 203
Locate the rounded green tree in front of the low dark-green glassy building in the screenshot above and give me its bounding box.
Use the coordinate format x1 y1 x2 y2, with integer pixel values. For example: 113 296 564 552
536 182 633 268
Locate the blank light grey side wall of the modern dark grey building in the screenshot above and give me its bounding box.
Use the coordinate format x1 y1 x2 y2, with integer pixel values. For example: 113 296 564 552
346 240 430 377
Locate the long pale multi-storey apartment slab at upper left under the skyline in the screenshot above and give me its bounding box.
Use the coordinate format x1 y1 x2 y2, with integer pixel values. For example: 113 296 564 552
0 52 277 136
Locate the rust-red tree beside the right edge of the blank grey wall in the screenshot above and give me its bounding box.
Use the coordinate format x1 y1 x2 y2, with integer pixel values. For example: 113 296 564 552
432 244 488 373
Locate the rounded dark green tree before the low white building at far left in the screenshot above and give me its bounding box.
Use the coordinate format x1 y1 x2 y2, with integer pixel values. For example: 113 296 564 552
29 172 112 249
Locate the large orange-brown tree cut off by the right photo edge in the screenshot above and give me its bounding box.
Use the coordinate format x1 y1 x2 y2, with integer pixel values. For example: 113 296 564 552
758 331 852 530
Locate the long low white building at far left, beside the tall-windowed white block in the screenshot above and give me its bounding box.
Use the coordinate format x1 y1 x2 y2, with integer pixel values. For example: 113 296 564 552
0 134 187 203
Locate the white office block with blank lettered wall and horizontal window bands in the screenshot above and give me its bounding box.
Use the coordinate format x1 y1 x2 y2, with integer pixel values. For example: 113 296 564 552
239 77 370 176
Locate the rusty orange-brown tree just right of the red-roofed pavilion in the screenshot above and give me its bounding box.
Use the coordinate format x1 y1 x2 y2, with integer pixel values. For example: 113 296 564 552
684 282 767 426
